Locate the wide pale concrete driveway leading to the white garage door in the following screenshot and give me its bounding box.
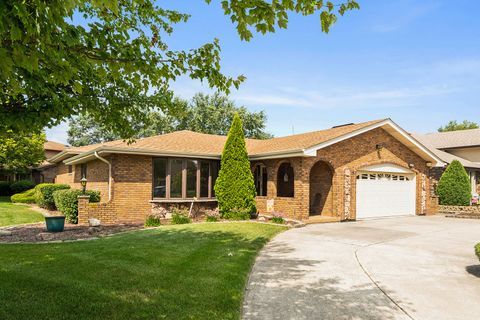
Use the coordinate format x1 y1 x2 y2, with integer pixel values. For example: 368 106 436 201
243 216 480 320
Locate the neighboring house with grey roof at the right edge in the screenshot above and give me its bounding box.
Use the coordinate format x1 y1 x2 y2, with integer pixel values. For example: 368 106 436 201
413 129 480 196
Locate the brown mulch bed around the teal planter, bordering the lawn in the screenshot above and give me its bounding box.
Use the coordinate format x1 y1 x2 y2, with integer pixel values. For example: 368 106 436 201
0 223 143 243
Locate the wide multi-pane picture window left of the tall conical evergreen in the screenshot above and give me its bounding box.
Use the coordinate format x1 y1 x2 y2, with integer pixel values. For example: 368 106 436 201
152 158 218 199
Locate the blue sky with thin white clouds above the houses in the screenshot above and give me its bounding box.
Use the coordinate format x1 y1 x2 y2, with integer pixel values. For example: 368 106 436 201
47 0 480 142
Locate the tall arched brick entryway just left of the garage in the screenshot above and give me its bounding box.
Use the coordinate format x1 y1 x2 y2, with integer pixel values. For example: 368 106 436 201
310 161 333 216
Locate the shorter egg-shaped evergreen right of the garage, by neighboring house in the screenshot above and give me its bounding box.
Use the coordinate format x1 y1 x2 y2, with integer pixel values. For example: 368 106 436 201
437 160 472 206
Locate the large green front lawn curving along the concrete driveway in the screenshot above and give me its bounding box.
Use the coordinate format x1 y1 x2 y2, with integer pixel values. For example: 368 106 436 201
0 223 285 320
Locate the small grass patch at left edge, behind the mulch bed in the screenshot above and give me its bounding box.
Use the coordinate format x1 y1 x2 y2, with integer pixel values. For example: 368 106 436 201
0 197 44 227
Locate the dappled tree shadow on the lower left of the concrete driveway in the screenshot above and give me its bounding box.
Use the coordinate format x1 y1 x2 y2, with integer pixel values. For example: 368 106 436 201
243 242 414 320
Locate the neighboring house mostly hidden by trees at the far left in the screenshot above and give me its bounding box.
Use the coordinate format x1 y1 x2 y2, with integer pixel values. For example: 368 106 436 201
0 141 67 184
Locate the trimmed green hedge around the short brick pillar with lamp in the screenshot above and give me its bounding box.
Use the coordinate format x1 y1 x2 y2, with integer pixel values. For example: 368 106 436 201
53 189 100 223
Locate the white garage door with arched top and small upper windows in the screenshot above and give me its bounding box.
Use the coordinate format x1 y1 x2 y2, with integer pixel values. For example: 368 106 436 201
356 165 416 219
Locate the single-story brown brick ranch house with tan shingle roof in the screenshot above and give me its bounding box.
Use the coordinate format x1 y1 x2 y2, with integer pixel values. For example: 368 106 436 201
49 119 443 223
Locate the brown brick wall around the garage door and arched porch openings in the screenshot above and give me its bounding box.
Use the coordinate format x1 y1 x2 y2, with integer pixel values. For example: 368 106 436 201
257 128 438 220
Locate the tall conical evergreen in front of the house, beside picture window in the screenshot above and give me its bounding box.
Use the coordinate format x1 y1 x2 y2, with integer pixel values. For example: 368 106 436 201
215 114 256 216
